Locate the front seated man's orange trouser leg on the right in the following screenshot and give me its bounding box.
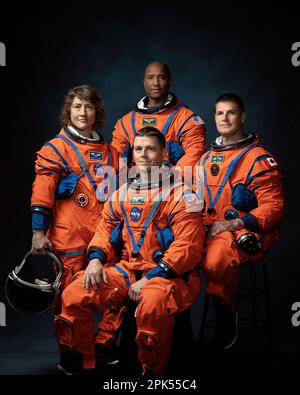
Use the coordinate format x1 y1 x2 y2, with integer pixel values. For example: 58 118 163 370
136 273 200 375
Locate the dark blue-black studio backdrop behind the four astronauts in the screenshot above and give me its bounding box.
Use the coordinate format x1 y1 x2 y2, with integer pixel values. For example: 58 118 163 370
0 1 300 374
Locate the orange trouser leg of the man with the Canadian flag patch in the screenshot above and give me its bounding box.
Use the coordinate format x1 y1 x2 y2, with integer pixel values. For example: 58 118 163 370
202 230 270 308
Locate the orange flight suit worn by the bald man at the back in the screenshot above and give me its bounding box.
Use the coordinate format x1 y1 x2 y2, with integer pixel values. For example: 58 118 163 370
95 94 205 345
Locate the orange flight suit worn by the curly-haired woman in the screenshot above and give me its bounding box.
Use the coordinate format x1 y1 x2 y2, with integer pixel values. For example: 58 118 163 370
31 127 118 285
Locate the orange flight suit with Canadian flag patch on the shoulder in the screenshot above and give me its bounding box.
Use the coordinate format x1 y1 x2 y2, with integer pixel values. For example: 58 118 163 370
195 134 284 308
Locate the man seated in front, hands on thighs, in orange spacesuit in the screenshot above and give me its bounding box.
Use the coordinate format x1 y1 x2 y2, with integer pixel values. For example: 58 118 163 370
55 127 204 375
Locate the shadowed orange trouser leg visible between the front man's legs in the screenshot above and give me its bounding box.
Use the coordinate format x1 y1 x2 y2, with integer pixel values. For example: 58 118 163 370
95 306 126 347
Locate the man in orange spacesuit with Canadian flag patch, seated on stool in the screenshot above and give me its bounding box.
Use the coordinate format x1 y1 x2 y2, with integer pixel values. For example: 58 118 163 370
195 93 284 349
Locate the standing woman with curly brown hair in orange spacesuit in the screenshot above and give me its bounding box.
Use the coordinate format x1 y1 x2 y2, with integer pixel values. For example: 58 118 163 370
31 85 118 294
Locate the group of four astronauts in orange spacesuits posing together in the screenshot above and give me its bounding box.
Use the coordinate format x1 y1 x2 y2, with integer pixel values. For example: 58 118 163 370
31 62 284 375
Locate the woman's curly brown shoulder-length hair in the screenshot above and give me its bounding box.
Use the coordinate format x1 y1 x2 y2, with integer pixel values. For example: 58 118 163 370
60 85 105 129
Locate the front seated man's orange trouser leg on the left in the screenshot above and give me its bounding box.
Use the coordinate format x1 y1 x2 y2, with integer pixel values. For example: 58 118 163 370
55 267 133 369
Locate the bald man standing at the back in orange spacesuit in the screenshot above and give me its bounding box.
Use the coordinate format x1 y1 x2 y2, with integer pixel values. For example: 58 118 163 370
95 61 205 360
